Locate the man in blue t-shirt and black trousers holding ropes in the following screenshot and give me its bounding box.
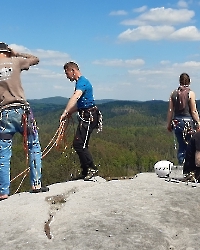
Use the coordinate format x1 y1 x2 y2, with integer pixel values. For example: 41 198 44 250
60 62 102 180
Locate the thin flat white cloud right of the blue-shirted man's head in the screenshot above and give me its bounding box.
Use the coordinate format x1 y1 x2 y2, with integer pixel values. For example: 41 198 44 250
93 59 145 67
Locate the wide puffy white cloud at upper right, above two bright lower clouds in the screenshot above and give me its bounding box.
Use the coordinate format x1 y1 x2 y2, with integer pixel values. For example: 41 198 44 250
121 7 195 25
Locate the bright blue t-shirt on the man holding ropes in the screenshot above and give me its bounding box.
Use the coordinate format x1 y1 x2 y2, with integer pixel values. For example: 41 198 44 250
75 76 95 109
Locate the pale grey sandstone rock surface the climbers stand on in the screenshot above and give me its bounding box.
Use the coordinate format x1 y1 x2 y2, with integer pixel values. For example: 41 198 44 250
0 173 200 250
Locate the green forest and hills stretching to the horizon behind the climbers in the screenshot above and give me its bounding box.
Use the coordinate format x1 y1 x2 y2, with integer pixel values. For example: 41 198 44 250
11 97 195 192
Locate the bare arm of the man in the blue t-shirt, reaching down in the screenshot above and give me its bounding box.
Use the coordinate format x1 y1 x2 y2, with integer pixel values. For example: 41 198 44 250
60 90 83 121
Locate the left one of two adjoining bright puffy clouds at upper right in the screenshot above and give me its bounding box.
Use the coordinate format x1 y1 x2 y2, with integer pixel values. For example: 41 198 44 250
118 26 175 41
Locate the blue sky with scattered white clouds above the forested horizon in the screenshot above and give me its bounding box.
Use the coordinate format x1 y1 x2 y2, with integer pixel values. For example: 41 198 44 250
1 0 200 101
